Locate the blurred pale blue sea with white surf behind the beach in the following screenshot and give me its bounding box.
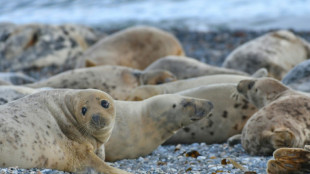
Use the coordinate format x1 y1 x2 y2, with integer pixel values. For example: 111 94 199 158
0 0 310 31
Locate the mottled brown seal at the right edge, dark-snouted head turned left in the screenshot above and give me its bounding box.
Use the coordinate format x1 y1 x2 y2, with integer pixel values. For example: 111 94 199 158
237 78 310 155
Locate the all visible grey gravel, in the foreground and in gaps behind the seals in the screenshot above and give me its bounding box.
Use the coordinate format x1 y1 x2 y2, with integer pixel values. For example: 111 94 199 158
0 29 310 174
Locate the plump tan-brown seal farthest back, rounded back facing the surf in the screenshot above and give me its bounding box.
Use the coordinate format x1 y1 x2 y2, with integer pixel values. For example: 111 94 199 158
76 26 185 70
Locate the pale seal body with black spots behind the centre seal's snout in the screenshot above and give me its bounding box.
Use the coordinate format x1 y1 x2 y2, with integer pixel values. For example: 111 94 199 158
166 83 257 144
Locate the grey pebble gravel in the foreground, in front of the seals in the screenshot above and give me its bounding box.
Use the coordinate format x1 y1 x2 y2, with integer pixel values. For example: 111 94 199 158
0 143 272 174
